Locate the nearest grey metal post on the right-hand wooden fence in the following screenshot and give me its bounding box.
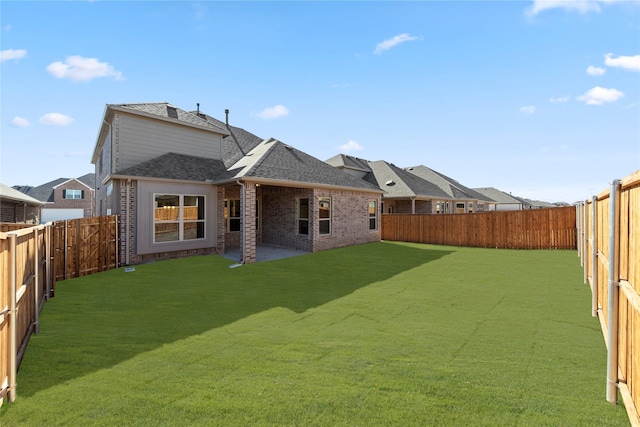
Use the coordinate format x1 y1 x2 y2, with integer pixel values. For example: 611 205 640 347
607 179 622 405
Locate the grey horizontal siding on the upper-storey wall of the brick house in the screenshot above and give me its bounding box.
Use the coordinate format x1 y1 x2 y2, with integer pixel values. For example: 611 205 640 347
114 114 222 173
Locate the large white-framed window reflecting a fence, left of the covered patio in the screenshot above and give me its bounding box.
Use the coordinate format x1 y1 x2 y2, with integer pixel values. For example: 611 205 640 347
153 194 205 243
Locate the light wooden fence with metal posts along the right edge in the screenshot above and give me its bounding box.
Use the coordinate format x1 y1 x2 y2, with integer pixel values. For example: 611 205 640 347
576 170 640 425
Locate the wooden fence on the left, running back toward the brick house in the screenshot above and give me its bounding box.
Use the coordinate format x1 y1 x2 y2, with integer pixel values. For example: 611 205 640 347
0 216 119 405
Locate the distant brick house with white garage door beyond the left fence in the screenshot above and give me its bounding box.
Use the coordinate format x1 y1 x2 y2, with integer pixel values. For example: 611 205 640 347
13 173 95 223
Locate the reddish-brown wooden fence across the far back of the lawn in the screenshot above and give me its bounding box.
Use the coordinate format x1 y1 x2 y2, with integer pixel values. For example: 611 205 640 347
381 206 577 249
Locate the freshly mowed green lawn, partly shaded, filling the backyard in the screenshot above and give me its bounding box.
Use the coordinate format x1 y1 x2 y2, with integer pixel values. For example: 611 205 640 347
0 242 629 426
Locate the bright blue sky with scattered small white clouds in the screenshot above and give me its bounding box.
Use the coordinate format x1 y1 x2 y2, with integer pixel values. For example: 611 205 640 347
0 0 640 203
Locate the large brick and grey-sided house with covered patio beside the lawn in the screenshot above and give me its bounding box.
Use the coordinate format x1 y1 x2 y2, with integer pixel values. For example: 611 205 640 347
92 103 382 264
